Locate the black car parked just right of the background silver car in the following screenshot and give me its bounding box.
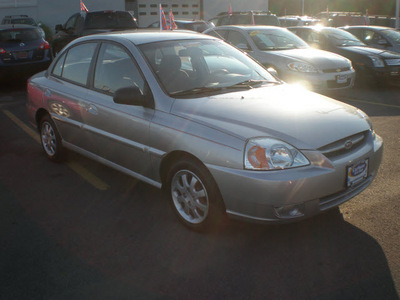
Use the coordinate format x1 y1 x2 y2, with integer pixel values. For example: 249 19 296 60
289 27 400 84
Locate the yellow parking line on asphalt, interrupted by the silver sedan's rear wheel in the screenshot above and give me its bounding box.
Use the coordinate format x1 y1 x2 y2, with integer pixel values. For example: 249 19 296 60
3 110 109 191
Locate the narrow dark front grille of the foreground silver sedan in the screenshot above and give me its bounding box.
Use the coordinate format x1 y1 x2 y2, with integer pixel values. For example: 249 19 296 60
318 131 368 158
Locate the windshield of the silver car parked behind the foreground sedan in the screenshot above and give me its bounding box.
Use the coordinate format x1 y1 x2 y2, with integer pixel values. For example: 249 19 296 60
247 29 309 51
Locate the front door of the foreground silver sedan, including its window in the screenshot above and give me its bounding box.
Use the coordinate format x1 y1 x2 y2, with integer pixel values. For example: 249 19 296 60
83 42 154 178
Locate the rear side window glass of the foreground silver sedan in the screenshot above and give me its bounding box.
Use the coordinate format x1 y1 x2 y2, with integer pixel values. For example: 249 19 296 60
57 43 97 85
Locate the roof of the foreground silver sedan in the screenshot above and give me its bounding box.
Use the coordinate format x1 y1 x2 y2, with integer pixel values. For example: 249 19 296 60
70 29 216 45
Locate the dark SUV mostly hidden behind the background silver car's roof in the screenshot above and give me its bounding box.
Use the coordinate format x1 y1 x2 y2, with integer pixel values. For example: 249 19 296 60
210 11 280 26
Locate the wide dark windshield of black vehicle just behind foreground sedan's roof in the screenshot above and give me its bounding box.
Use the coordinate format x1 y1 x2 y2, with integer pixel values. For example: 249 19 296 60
85 12 137 29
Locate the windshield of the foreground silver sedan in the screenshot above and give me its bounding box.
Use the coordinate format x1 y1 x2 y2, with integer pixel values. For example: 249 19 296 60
139 39 280 97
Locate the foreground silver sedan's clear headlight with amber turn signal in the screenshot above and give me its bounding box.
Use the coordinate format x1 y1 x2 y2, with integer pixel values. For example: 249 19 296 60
244 138 310 170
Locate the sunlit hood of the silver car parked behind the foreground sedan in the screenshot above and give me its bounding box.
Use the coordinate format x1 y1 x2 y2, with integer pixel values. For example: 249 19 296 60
268 48 349 69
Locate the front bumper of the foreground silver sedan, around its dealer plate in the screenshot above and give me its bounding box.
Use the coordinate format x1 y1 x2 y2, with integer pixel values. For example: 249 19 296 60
208 131 383 223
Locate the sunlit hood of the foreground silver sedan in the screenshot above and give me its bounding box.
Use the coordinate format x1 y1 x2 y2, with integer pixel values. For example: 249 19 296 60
171 84 370 150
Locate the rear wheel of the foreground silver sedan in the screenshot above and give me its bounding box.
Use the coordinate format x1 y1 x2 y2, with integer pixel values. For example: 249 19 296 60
39 115 64 162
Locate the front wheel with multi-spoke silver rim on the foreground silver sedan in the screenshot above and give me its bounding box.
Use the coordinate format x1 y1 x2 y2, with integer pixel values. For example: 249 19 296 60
167 160 225 231
